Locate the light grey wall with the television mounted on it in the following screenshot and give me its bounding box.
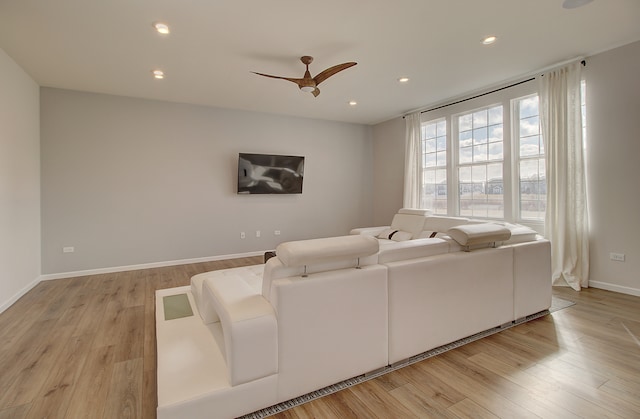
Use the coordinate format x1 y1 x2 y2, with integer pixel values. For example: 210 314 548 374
41 88 373 274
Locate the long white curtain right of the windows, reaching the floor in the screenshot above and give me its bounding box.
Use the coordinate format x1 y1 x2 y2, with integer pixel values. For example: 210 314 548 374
538 62 589 291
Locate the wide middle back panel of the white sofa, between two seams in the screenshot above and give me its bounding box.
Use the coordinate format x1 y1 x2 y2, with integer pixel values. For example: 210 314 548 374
387 247 513 364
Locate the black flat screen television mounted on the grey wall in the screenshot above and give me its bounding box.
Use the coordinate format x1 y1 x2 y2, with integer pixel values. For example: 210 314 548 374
238 153 304 194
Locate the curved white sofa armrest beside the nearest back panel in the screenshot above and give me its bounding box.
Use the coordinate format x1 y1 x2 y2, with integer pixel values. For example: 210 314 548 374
203 277 278 386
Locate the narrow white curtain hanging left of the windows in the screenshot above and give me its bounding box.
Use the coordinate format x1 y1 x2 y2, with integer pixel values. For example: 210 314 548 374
402 112 422 208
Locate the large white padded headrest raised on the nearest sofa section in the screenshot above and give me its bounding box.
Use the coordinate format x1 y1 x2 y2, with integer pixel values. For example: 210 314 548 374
276 235 378 266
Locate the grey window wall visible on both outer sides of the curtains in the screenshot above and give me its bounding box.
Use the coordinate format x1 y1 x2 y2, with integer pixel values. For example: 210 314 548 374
373 42 640 295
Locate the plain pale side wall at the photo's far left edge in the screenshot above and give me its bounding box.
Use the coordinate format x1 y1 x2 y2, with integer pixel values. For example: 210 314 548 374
0 49 40 312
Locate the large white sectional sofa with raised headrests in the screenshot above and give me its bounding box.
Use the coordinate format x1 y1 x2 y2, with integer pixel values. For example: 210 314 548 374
156 210 551 419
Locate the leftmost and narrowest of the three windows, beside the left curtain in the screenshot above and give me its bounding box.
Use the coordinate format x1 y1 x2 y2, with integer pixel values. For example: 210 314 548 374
421 118 447 214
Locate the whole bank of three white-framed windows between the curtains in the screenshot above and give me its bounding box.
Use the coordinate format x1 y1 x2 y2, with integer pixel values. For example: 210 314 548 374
421 82 546 229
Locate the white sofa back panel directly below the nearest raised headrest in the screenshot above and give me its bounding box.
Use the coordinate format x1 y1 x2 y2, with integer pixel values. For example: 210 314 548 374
271 265 388 400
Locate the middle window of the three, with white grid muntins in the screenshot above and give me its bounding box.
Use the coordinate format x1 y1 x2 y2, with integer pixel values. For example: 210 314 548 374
456 106 504 218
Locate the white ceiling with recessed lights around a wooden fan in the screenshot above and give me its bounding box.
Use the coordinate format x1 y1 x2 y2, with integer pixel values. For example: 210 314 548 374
0 0 640 124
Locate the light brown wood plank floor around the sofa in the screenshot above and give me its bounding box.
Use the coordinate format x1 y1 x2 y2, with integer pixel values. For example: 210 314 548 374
0 257 640 419
